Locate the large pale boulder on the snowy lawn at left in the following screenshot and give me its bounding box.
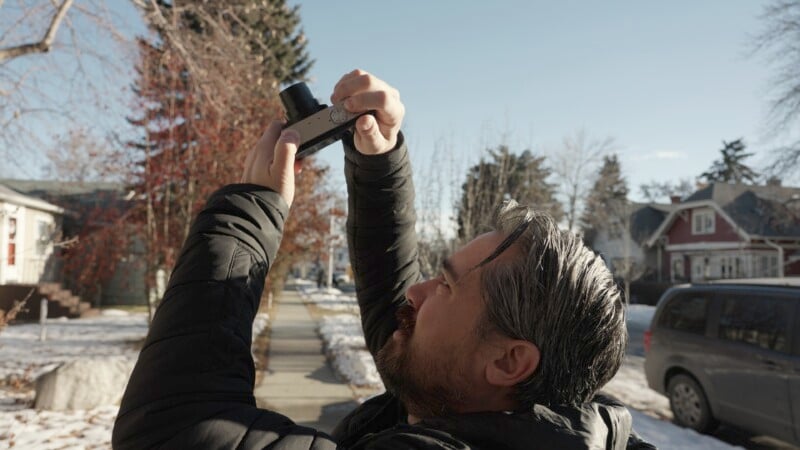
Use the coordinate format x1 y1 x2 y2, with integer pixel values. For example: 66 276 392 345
34 357 135 411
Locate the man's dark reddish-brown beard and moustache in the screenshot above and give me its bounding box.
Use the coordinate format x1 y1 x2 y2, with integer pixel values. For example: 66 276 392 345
375 305 468 418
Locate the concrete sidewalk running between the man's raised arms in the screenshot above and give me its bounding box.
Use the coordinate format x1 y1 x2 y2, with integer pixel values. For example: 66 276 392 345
255 286 357 432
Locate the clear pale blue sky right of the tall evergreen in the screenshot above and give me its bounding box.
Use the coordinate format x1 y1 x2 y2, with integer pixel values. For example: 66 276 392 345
291 0 792 200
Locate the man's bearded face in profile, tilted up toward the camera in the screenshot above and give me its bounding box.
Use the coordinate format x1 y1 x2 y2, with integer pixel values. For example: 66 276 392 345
376 232 503 417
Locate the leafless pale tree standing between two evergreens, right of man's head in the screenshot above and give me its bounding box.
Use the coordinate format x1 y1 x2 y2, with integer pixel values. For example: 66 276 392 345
550 129 616 231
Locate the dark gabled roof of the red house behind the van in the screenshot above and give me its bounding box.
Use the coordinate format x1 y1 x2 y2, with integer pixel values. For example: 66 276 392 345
648 183 800 245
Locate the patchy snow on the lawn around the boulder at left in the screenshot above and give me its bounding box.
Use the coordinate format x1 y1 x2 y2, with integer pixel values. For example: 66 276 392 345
0 310 268 450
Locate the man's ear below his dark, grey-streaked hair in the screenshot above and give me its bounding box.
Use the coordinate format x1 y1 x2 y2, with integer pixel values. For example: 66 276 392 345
486 339 541 386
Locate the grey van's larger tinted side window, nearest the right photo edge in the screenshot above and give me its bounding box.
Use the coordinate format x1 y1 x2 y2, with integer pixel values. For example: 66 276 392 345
719 294 793 353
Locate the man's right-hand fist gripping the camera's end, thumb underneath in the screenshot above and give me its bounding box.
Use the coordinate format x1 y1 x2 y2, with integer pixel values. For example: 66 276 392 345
331 69 405 155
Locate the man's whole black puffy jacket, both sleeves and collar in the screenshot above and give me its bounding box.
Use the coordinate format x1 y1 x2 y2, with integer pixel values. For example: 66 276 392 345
112 137 652 450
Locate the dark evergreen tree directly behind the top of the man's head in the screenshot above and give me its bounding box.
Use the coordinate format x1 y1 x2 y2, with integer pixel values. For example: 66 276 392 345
457 145 563 242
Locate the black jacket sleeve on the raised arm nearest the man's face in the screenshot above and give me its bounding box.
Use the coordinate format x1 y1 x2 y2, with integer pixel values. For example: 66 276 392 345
343 134 420 356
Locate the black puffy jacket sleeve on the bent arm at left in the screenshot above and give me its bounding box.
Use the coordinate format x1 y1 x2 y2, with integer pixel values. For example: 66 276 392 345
112 184 335 449
